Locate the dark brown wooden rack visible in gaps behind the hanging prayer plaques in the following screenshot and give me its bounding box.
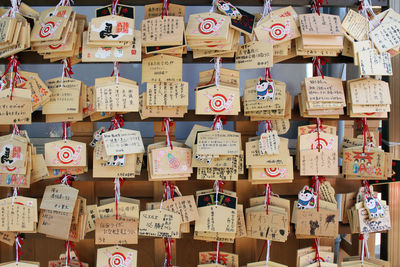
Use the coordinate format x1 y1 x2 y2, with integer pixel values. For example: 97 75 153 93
0 0 389 267
